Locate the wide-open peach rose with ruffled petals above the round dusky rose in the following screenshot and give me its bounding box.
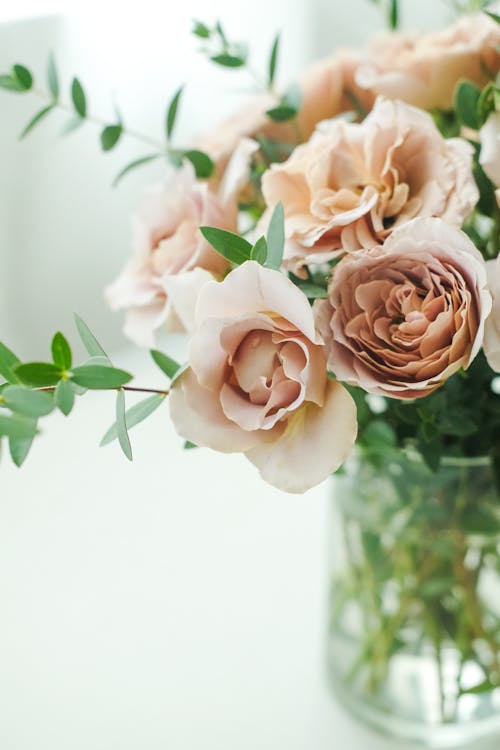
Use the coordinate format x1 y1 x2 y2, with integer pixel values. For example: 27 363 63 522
262 98 478 269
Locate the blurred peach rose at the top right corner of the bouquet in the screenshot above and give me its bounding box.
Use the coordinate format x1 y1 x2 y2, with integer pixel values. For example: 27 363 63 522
356 13 500 109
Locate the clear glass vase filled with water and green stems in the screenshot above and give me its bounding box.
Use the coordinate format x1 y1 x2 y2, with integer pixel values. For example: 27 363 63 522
328 452 500 748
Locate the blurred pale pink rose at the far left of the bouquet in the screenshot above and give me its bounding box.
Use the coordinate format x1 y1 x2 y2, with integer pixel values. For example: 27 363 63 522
105 140 257 347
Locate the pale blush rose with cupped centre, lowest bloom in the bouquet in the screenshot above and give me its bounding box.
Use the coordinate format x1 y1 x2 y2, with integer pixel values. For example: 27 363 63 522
170 261 357 492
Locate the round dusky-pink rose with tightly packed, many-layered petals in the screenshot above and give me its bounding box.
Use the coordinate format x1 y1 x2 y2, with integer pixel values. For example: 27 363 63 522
316 219 491 399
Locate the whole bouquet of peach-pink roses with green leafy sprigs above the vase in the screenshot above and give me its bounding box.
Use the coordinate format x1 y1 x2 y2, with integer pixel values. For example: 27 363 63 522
0 3 500 492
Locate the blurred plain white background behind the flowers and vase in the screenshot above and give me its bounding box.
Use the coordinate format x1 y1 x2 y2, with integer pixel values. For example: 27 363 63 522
0 0 453 750
